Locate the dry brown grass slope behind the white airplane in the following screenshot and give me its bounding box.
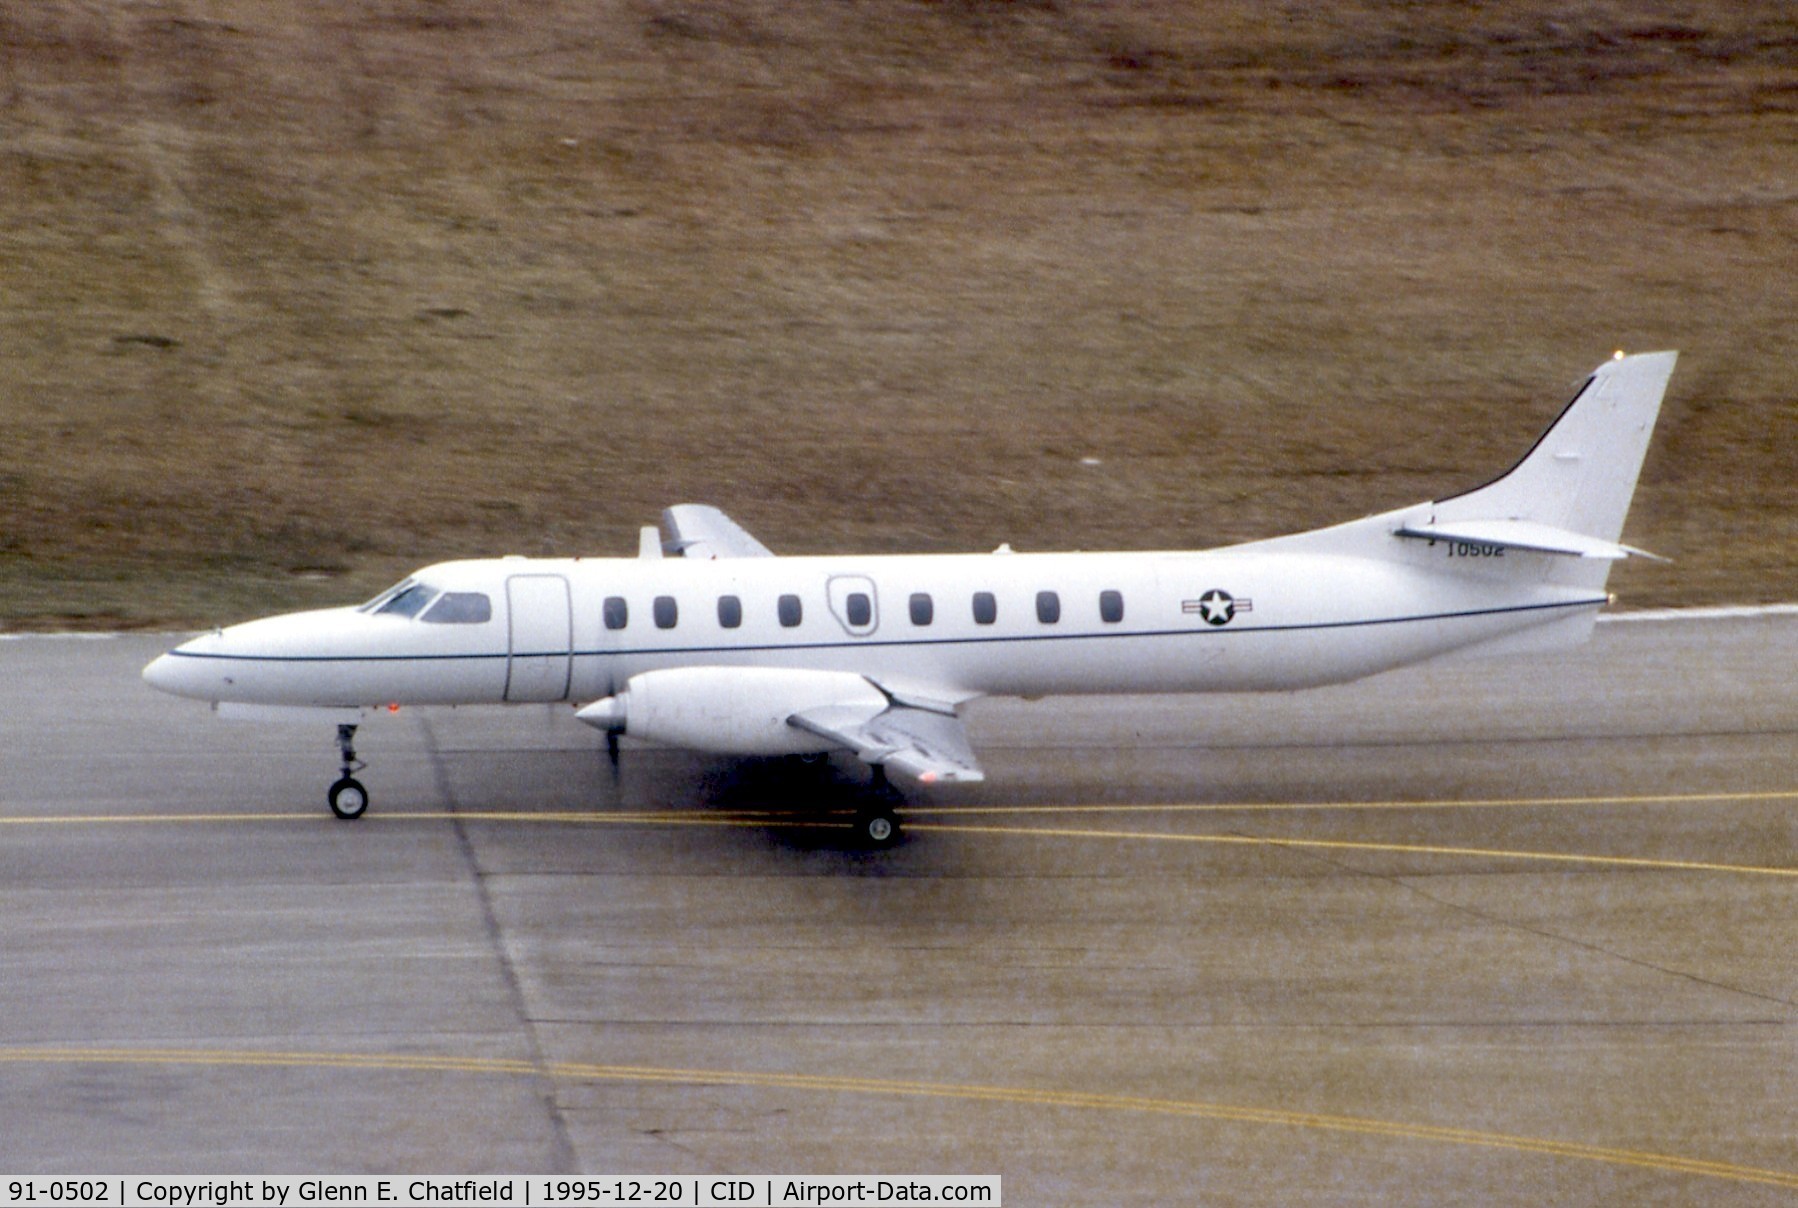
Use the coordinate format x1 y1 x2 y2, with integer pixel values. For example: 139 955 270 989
0 0 1798 627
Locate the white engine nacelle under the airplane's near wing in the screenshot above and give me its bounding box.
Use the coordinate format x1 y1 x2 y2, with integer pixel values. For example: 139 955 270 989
575 667 888 755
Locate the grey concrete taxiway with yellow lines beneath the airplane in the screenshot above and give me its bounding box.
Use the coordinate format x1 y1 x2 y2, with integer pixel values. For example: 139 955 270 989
0 615 1798 1204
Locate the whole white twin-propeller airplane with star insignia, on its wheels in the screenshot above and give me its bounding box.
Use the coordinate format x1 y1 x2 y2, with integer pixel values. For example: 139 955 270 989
144 352 1678 845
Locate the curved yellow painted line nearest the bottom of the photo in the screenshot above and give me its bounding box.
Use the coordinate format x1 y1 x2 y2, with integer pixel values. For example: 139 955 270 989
0 1046 1798 1190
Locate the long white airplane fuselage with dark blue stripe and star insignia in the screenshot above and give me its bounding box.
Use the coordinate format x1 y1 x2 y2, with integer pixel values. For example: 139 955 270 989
146 543 1606 706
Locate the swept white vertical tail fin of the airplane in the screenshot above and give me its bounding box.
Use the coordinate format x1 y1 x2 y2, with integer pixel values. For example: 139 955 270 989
1431 352 1679 557
